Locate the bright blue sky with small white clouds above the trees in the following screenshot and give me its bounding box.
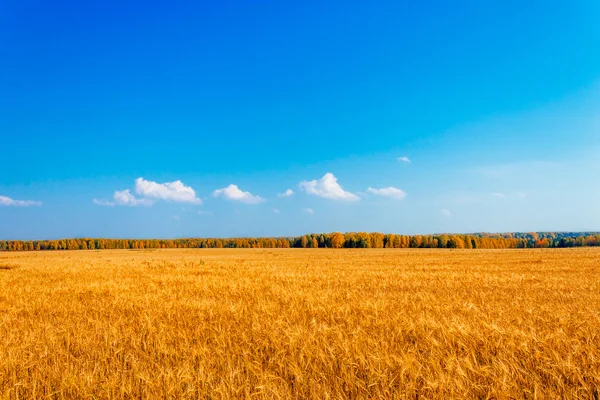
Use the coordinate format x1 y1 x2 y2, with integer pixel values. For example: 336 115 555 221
0 0 600 239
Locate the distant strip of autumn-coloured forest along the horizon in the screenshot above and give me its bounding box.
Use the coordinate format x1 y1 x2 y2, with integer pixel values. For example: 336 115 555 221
0 232 600 251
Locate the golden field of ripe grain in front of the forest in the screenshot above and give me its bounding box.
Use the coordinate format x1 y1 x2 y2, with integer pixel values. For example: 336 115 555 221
0 248 600 399
